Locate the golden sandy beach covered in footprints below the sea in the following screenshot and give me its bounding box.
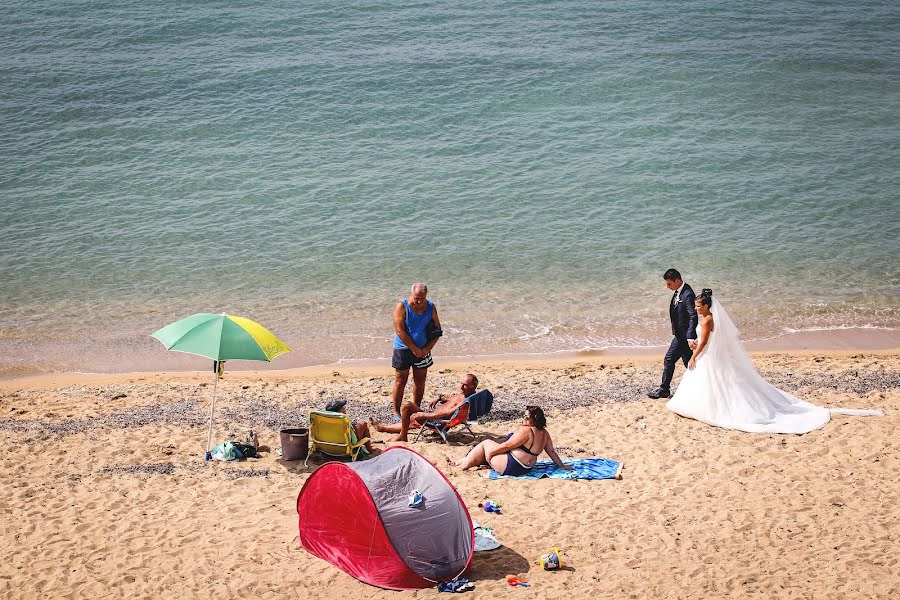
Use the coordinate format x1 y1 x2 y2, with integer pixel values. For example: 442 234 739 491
0 350 900 599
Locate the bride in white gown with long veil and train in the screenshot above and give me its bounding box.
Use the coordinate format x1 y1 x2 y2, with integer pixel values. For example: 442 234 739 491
666 289 884 433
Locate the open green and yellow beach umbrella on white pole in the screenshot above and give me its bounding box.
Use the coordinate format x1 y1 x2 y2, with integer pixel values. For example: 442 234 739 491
150 313 291 460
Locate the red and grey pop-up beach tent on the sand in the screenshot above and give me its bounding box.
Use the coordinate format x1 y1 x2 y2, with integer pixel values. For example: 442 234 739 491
297 446 474 590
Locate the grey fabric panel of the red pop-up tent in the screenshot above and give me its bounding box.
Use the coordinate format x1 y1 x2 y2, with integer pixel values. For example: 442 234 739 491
347 448 472 581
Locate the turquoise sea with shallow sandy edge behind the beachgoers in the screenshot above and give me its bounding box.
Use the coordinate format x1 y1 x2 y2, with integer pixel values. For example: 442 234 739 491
0 0 900 374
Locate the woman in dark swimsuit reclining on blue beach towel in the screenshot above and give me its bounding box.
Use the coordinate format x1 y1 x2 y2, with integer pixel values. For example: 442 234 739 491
456 406 572 475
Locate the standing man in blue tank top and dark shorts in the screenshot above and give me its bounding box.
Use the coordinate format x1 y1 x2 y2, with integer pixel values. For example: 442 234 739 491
391 283 442 418
